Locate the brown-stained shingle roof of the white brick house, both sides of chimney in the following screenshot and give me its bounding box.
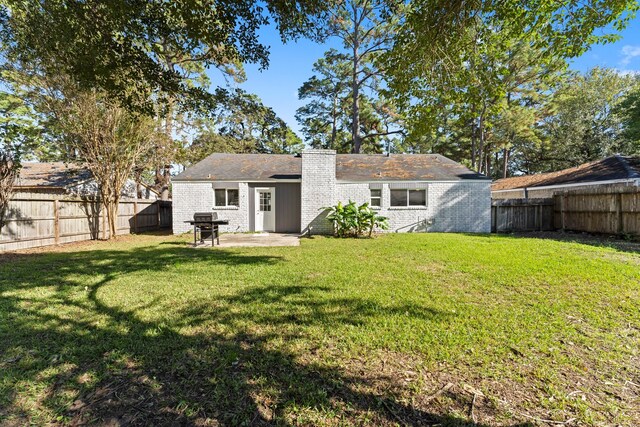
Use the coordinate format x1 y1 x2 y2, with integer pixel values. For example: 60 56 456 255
174 153 488 181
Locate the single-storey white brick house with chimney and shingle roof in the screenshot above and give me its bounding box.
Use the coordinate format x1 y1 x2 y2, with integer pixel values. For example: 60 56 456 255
173 150 491 234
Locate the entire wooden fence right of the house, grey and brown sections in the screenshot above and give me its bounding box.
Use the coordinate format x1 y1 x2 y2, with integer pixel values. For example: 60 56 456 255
491 187 640 235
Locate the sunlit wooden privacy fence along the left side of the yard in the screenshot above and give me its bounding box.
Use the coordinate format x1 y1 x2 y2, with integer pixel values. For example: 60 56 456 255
0 198 171 251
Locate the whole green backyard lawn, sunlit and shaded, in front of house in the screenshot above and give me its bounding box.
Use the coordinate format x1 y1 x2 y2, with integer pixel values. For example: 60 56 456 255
0 234 640 426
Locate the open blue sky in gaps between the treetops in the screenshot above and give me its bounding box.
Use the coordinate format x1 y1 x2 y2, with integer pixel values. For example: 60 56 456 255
212 18 640 136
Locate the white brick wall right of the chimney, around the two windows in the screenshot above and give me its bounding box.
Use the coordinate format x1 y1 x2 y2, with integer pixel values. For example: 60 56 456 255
332 181 491 233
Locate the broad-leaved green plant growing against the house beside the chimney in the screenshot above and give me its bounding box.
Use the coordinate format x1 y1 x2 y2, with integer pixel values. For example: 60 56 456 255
323 200 389 237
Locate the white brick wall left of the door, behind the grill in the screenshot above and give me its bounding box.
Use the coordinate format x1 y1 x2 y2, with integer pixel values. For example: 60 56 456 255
172 181 249 234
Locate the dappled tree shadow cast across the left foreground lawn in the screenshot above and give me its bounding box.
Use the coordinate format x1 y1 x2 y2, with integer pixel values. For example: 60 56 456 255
0 247 528 426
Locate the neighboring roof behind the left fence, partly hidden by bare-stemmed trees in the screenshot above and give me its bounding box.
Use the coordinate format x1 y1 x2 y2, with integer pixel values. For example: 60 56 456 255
14 162 91 188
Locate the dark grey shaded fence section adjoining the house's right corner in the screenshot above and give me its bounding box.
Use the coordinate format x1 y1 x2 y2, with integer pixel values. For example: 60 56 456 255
491 199 554 233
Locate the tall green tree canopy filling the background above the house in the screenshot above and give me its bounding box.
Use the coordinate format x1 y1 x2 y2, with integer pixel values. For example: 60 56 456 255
0 0 640 184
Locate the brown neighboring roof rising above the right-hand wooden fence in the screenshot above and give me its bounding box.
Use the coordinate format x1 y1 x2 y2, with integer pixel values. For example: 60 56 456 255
491 155 640 191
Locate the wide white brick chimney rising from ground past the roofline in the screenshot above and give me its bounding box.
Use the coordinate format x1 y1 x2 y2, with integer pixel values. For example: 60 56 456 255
300 150 337 234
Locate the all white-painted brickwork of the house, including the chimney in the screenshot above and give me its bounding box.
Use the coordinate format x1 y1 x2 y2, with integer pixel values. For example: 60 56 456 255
173 150 491 234
